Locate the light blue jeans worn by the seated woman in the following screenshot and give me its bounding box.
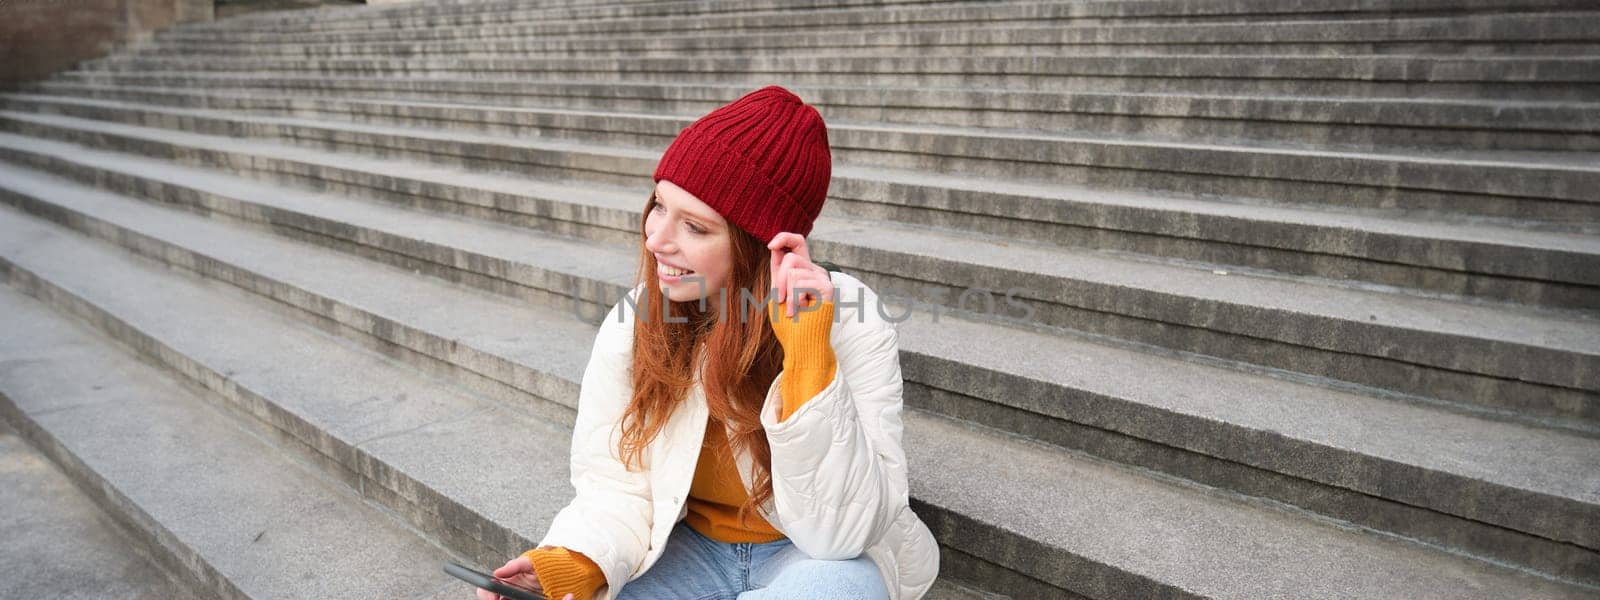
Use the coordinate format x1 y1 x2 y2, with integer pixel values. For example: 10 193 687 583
616 520 890 600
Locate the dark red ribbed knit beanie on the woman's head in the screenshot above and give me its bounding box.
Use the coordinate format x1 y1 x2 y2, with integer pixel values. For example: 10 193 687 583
654 85 834 242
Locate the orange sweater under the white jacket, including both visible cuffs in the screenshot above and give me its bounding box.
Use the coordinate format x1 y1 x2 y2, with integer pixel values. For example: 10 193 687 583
523 299 838 600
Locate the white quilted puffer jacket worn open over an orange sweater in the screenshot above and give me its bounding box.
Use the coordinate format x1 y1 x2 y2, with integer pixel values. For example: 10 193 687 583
539 272 939 600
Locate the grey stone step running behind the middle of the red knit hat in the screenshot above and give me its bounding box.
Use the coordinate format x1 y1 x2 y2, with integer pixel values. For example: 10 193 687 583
0 96 1600 230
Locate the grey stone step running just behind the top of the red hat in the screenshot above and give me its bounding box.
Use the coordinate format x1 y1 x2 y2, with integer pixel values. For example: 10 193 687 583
22 74 1600 152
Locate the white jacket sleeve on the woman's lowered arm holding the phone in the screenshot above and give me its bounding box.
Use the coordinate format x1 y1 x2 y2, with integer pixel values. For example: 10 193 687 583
539 288 653 597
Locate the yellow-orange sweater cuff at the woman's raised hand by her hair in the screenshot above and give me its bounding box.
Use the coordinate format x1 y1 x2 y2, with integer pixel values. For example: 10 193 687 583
771 301 838 421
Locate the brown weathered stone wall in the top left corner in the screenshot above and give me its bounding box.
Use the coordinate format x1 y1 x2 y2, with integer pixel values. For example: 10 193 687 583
0 0 213 86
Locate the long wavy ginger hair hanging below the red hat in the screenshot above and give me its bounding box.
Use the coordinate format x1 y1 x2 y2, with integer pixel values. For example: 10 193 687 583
618 190 784 525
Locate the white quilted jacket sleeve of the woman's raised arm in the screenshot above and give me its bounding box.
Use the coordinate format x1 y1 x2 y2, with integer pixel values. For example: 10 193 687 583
762 274 910 560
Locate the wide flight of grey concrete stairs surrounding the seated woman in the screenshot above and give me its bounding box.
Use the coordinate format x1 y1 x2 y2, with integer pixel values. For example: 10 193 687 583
0 0 1600 598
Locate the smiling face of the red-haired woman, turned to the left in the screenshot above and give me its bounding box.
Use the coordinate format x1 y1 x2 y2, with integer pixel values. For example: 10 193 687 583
645 179 734 302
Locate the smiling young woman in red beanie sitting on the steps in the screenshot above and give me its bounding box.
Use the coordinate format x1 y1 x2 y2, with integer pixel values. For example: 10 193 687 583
480 85 939 600
